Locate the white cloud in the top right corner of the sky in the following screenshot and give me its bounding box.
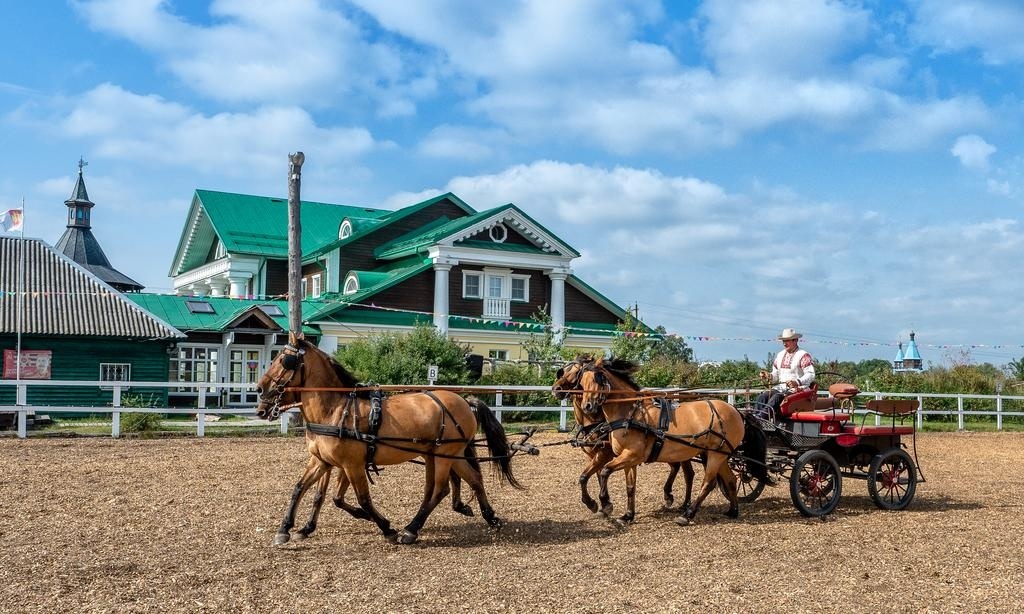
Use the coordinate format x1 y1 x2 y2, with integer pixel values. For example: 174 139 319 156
910 0 1024 64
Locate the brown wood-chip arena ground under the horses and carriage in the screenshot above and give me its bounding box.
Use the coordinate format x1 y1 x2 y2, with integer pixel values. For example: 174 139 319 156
0 434 1024 613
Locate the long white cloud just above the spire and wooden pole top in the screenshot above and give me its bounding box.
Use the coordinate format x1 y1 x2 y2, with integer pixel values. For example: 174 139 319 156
59 84 382 176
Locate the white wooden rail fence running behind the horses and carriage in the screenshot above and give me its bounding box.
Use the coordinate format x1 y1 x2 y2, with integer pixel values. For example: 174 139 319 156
0 380 1024 438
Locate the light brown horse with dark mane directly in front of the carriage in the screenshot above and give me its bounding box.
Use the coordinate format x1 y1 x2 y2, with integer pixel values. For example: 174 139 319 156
580 358 743 525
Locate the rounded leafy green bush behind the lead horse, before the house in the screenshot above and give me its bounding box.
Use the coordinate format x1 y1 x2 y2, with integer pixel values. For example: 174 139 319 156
335 324 469 385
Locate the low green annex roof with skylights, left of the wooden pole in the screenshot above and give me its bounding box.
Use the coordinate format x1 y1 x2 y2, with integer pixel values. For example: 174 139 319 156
123 293 321 336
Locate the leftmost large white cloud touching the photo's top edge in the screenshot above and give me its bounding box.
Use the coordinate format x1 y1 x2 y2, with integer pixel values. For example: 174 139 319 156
75 0 433 108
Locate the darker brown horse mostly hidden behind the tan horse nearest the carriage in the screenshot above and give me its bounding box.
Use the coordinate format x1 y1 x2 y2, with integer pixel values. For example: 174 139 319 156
551 354 693 522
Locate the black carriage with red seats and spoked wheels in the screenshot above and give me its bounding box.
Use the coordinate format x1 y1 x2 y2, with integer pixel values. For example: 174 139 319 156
730 383 925 517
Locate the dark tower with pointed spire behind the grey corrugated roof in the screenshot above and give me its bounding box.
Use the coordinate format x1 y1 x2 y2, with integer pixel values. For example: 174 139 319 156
54 158 142 292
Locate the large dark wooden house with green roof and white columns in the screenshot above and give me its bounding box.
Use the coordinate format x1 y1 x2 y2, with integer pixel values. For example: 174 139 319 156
163 189 626 364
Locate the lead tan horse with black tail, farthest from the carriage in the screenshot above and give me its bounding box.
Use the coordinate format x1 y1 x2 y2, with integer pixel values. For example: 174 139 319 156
256 334 522 545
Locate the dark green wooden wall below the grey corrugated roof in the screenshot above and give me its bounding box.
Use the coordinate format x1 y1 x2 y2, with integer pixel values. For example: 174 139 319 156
0 335 170 407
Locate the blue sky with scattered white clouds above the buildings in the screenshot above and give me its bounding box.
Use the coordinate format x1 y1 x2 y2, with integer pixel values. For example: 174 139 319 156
0 0 1024 365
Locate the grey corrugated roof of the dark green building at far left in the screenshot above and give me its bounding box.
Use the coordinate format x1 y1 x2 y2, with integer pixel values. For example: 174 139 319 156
0 236 184 339
